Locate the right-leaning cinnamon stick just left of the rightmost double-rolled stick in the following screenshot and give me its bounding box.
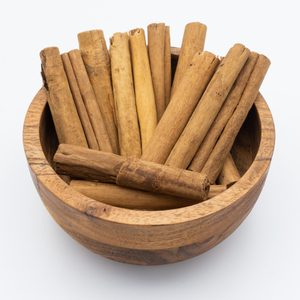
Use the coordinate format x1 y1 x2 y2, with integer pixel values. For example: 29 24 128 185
166 44 250 169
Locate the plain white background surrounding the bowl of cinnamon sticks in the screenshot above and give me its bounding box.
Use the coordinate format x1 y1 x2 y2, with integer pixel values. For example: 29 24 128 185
0 0 300 300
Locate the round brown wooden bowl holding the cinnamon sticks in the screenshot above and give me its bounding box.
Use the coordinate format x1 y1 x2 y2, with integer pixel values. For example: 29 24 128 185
23 51 275 265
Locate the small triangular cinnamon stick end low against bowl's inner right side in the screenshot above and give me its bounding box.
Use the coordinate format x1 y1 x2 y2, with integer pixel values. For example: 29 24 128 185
217 153 241 185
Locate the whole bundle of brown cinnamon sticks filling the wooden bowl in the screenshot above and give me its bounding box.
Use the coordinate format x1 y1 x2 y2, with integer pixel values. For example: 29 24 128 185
40 22 270 209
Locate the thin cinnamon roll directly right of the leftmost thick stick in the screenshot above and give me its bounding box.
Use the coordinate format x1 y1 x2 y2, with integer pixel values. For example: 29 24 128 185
61 53 99 150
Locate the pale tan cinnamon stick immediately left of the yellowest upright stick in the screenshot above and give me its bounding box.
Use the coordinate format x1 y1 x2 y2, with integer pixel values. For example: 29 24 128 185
110 33 142 158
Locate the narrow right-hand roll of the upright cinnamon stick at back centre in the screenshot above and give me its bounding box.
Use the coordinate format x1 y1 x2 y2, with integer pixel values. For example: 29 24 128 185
164 26 172 107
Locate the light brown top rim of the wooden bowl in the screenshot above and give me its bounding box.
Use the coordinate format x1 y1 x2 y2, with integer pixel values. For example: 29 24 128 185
23 73 275 226
